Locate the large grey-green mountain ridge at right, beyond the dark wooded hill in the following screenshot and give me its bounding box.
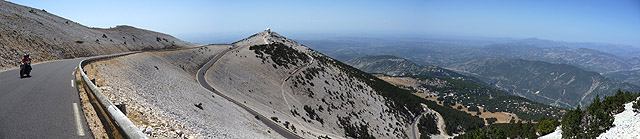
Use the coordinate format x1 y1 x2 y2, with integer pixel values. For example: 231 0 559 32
451 58 640 108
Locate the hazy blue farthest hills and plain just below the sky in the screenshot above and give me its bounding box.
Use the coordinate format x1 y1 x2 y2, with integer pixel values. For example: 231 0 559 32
302 39 640 73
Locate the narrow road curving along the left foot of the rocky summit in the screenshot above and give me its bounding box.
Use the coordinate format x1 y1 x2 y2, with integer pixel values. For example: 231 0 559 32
197 46 301 139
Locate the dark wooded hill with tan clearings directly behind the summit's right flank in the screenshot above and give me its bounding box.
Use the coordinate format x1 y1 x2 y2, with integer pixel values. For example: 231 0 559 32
346 55 561 121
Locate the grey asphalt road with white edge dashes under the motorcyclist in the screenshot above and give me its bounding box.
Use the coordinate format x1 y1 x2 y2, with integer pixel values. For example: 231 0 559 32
0 59 93 139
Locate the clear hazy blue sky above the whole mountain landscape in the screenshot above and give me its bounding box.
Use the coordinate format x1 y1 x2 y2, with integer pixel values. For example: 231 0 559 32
11 0 640 46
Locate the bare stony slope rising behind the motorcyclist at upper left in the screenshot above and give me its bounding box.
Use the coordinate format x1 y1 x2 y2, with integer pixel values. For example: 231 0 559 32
0 1 195 70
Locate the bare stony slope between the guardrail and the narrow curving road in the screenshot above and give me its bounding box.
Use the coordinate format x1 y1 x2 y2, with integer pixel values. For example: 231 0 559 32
84 45 282 138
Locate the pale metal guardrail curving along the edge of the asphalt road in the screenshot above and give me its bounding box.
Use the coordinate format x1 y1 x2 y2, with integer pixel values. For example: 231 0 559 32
78 51 148 139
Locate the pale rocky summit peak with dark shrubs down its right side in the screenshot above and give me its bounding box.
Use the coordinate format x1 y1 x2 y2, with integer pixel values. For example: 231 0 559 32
205 30 480 138
